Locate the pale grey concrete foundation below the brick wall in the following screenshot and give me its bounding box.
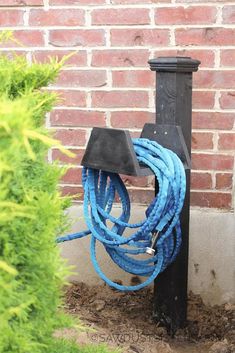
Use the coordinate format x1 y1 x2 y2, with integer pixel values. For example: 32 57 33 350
60 205 235 305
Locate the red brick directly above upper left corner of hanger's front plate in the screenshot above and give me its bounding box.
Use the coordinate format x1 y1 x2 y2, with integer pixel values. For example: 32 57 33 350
51 109 106 127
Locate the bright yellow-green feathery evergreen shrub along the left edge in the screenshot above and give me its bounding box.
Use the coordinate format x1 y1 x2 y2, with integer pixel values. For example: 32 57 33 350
0 48 75 353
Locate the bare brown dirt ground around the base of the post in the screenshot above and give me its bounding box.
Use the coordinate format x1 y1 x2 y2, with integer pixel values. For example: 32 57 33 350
63 283 235 353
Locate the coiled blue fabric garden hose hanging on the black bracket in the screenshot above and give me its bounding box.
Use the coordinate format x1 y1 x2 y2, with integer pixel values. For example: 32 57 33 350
57 138 186 291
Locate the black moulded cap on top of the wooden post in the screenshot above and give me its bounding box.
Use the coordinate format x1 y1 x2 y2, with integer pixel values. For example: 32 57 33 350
148 56 201 72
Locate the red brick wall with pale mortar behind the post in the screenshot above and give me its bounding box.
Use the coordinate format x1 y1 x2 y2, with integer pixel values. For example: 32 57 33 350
0 0 235 209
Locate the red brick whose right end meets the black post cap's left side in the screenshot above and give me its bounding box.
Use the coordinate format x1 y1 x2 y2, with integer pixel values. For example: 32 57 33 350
92 49 149 67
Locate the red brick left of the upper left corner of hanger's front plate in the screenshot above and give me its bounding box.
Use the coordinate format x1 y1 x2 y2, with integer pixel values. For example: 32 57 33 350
54 129 86 146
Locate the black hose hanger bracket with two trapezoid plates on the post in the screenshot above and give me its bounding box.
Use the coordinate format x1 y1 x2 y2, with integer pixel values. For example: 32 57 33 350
81 124 191 176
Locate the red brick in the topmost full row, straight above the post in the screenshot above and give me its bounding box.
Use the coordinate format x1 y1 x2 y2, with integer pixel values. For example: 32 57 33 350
155 6 216 25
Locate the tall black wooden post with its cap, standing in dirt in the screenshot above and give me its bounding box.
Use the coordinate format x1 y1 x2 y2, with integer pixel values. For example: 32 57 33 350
149 57 200 335
